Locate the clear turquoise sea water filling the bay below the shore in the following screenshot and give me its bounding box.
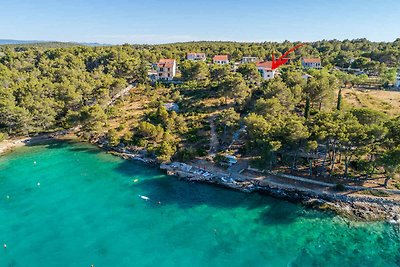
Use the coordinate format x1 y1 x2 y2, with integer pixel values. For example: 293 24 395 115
0 142 400 267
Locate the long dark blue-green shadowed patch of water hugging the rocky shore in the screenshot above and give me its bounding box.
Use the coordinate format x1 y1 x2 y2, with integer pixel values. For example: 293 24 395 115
111 161 318 224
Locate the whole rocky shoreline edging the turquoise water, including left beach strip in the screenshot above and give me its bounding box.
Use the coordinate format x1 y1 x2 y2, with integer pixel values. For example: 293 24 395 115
0 135 400 224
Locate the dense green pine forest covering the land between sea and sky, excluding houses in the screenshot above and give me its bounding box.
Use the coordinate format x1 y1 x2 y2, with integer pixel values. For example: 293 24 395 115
0 39 400 186
